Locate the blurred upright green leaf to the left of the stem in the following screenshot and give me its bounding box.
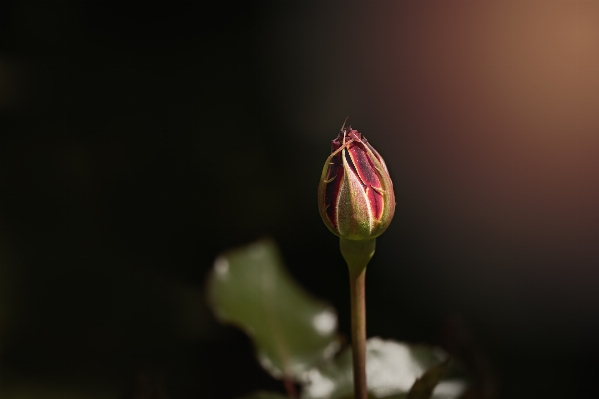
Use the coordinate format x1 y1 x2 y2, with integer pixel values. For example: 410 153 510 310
208 240 339 380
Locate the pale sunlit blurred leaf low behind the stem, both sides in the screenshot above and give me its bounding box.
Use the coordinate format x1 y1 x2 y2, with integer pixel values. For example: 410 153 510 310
302 338 465 399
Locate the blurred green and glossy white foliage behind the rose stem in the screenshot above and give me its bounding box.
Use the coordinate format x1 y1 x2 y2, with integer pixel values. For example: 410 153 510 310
208 241 466 399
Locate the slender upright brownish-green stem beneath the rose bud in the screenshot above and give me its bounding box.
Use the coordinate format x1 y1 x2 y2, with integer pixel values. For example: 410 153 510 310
340 238 376 399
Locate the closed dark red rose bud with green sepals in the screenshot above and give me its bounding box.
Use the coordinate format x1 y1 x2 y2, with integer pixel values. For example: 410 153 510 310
318 126 395 240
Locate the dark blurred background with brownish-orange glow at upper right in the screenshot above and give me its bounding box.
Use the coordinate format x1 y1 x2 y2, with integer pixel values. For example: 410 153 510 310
0 0 599 399
